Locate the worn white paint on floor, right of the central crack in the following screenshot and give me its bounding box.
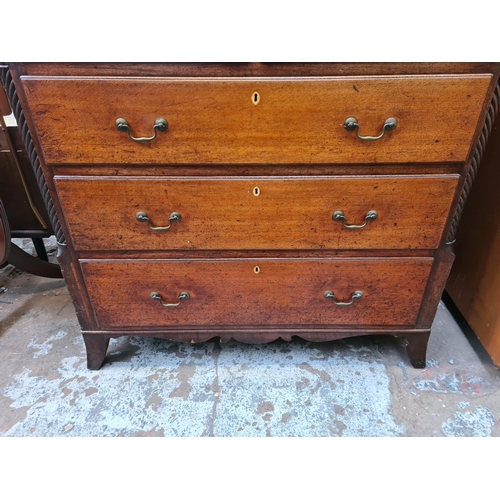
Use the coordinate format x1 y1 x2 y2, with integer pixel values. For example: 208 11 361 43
214 344 404 437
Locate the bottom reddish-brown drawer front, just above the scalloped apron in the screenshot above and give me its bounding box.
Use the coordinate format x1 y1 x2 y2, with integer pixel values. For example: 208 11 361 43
81 258 433 329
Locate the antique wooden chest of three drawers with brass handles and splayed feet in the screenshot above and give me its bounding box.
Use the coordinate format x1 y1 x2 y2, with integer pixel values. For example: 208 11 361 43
4 63 498 369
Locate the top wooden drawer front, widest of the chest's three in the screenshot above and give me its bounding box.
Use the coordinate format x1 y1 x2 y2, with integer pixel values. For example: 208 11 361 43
23 75 491 164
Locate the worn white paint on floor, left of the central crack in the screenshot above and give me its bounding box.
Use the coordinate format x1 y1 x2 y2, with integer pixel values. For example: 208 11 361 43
0 338 214 437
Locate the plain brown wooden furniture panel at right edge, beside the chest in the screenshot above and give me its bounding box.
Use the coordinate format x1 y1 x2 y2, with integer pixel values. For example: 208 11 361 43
446 86 500 367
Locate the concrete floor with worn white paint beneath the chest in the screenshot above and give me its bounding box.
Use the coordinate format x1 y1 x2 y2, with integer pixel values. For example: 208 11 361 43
0 240 500 436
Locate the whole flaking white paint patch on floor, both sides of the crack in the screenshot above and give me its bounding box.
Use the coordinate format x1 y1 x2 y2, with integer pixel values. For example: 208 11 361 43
0 338 404 437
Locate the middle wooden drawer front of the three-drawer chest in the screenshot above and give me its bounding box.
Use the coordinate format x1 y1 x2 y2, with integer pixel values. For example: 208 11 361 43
55 175 458 254
